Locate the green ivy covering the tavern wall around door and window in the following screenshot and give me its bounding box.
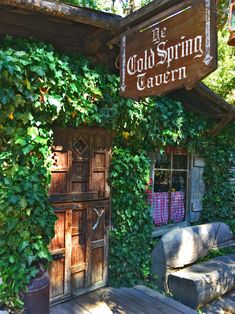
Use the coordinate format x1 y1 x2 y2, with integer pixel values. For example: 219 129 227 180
0 37 235 308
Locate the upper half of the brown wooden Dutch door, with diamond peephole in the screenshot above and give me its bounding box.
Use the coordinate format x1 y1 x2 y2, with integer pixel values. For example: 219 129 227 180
49 128 111 202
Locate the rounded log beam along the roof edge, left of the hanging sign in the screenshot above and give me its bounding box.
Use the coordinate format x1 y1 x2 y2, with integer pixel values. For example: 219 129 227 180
0 0 122 30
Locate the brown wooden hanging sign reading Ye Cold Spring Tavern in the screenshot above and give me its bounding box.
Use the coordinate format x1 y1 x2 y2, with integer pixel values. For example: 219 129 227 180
120 0 217 99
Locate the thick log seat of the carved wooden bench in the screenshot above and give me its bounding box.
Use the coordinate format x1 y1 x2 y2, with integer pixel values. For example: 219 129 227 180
168 254 235 309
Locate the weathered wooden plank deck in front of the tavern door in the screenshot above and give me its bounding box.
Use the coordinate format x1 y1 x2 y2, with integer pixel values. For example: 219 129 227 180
50 286 197 314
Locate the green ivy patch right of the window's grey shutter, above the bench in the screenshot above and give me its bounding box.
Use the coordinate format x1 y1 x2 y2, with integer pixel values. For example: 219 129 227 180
202 124 235 222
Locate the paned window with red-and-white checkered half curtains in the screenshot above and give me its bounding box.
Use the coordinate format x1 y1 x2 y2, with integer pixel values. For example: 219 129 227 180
151 148 189 226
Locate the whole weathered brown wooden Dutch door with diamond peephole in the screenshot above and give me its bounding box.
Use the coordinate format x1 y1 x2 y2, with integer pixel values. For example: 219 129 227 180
49 128 111 302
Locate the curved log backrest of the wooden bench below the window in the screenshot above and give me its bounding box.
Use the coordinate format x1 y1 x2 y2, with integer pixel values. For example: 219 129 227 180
152 222 234 291
